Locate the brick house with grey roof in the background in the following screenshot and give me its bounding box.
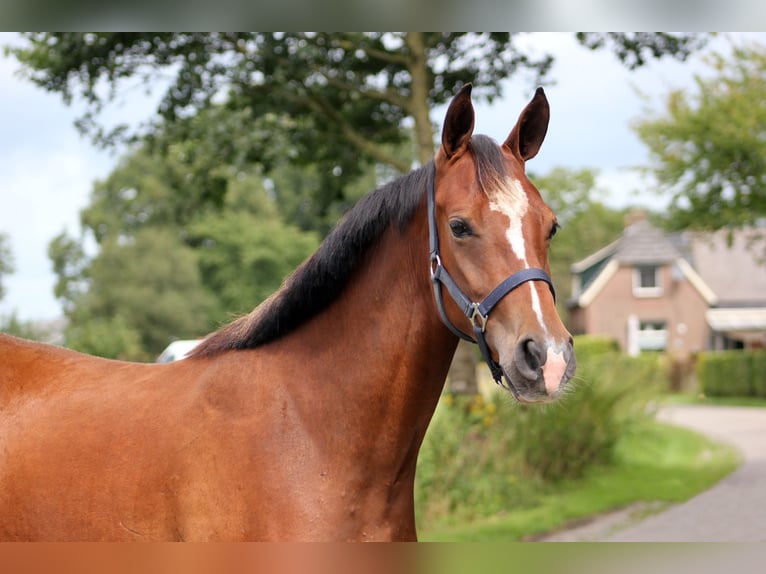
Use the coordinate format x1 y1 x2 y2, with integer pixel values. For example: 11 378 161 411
568 215 766 356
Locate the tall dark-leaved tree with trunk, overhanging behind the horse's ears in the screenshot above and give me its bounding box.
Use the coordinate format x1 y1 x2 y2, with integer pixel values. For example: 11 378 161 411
11 32 704 390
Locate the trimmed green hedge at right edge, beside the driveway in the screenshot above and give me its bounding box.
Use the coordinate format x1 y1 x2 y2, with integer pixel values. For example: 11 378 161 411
697 350 766 398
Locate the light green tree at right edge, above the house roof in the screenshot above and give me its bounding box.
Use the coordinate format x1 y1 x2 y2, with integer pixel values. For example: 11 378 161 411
635 44 766 236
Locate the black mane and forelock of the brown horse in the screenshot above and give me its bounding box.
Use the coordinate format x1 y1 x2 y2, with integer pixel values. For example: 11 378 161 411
190 136 503 356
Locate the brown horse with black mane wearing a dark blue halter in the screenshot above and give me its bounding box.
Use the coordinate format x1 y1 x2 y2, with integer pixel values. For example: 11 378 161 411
0 86 575 541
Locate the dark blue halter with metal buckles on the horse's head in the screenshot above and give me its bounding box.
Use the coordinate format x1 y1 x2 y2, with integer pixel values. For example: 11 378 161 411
427 169 556 389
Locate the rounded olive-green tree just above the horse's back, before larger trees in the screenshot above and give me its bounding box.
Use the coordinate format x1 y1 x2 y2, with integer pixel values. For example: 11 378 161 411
66 227 219 359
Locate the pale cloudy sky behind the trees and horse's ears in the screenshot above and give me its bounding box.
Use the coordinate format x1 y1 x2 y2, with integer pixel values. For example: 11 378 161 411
0 32 766 321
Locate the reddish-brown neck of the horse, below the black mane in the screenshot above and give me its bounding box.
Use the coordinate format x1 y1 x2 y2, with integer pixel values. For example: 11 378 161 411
285 220 457 450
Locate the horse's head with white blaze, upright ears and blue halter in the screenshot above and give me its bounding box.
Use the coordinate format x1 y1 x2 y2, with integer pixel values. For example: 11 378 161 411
432 85 575 402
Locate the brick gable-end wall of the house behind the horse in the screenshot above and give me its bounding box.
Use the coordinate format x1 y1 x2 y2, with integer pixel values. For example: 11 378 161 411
570 265 709 355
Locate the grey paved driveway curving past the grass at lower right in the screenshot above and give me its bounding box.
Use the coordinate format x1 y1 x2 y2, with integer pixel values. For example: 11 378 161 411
545 406 766 542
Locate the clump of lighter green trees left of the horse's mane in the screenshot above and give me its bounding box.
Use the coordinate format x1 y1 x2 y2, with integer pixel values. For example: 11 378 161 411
49 140 319 360
